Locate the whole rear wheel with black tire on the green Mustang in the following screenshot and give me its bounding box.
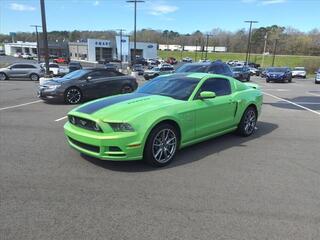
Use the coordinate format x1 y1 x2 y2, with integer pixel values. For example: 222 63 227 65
237 107 258 137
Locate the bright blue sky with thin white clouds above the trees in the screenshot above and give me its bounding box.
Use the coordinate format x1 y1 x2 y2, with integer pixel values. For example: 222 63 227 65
0 0 320 33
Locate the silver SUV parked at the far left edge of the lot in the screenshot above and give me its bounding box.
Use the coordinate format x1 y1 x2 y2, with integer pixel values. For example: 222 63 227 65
0 63 44 81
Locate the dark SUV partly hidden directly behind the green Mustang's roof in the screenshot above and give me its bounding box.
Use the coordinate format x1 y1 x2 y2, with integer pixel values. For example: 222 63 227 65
175 60 233 77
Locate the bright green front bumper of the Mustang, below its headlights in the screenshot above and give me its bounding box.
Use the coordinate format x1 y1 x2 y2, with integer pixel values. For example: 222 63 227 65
64 122 143 161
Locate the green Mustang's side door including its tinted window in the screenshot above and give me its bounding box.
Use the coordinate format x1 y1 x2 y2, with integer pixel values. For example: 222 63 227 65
194 78 237 138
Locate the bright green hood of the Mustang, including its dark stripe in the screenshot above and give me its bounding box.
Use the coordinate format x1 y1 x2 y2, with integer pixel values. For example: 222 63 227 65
70 92 182 122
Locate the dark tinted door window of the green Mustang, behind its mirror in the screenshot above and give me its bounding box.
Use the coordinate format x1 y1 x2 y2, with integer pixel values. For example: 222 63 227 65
198 78 231 96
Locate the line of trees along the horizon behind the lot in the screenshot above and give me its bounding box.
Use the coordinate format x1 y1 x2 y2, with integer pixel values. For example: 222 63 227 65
0 25 320 56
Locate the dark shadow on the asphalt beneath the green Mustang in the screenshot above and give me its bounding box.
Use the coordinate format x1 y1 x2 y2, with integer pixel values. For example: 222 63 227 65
81 122 278 172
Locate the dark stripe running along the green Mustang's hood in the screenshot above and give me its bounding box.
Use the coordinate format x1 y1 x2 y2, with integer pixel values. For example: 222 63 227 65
77 93 148 114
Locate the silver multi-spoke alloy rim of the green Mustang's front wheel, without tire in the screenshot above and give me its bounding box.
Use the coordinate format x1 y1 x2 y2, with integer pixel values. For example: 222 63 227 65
152 128 177 163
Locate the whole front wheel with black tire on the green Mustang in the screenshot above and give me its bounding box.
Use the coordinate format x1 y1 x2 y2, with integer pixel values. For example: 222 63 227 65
143 123 179 167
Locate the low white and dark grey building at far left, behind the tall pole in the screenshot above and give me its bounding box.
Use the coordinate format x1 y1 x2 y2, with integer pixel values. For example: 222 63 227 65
4 41 69 57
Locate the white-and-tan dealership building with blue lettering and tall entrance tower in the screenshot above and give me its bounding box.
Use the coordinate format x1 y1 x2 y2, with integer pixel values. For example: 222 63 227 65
69 36 157 62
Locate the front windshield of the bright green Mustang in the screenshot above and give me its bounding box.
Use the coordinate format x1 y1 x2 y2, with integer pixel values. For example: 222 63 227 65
138 76 199 101
